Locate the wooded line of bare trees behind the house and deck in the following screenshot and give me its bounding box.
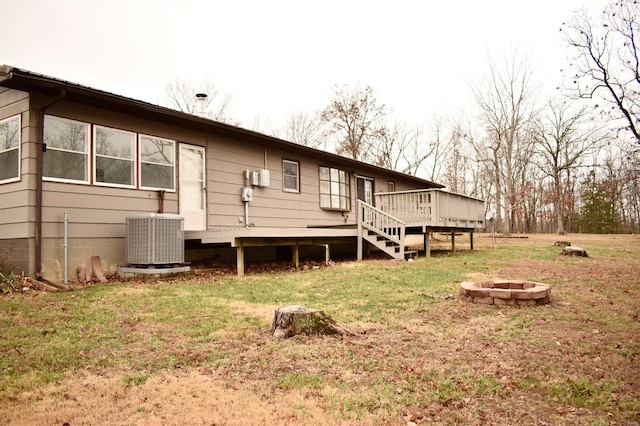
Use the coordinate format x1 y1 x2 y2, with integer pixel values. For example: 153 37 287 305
166 0 640 233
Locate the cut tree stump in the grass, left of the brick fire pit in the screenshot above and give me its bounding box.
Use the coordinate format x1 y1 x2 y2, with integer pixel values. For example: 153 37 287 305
270 305 354 339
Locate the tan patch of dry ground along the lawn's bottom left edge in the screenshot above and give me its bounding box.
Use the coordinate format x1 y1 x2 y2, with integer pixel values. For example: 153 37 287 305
5 369 338 425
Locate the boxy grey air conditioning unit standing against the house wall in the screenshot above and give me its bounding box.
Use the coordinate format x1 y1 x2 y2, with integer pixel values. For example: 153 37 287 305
125 214 184 265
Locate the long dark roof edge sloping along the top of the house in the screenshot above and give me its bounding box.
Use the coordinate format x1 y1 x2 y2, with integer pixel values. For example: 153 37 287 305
0 65 444 188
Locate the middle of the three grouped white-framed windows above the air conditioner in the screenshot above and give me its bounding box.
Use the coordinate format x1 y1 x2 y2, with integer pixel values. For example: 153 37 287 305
93 126 136 188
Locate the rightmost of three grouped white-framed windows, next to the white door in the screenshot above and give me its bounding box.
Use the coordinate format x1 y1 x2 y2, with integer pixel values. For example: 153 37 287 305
139 135 176 191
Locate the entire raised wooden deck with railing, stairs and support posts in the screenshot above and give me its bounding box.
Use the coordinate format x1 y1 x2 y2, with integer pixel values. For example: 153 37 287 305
184 189 485 275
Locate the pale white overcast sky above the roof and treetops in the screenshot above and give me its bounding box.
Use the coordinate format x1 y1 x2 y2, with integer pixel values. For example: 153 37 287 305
0 0 607 129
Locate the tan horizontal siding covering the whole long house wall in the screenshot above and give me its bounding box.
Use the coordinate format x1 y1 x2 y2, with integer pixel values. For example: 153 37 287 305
0 89 436 280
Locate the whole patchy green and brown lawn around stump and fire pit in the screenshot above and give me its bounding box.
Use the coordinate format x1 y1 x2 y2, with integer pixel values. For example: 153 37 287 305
0 235 640 425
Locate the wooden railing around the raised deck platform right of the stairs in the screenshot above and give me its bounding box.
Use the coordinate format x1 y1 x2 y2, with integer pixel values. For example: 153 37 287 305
375 189 485 228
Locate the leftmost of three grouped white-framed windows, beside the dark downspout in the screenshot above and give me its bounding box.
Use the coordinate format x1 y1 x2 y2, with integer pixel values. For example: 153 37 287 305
43 115 89 183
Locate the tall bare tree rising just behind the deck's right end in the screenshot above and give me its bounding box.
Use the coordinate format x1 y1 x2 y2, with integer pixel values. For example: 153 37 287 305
474 54 536 233
